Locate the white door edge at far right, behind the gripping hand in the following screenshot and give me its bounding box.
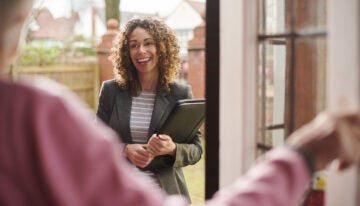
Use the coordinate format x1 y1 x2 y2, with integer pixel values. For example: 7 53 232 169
325 0 360 206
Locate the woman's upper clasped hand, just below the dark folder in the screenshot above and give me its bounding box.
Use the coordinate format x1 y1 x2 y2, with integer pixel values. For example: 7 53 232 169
147 134 176 157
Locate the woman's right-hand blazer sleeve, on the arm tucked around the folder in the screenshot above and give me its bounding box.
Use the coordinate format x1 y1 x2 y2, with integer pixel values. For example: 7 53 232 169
173 86 203 167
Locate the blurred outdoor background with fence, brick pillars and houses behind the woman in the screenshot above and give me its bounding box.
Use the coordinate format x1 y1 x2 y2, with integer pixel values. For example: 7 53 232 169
9 0 205 109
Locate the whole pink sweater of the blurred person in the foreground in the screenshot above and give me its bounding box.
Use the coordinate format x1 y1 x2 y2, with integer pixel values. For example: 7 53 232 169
0 80 310 206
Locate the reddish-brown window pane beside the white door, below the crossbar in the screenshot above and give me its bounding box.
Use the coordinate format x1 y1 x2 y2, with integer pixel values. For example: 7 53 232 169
294 38 326 128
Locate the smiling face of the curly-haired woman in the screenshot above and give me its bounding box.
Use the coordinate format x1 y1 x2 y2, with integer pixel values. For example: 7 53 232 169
128 27 159 75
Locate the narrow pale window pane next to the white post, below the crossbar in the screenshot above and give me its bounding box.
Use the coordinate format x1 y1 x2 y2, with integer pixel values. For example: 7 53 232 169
258 39 287 152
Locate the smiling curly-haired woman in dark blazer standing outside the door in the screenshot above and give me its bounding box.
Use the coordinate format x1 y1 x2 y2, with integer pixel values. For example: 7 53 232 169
97 18 202 200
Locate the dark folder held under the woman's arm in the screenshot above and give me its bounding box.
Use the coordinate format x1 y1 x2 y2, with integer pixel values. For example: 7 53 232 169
143 99 205 171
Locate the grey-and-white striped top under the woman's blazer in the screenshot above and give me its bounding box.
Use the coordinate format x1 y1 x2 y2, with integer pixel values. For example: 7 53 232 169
130 91 155 143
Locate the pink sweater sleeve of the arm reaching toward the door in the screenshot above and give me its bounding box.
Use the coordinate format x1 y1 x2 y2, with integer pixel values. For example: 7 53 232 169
207 148 310 206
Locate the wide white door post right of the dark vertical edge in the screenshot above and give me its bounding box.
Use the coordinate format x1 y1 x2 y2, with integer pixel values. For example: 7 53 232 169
220 0 257 187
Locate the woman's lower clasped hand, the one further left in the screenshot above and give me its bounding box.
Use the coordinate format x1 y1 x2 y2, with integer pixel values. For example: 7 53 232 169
125 144 153 168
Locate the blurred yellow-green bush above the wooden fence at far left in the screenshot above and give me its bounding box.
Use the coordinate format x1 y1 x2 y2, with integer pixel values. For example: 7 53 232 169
20 40 61 66
